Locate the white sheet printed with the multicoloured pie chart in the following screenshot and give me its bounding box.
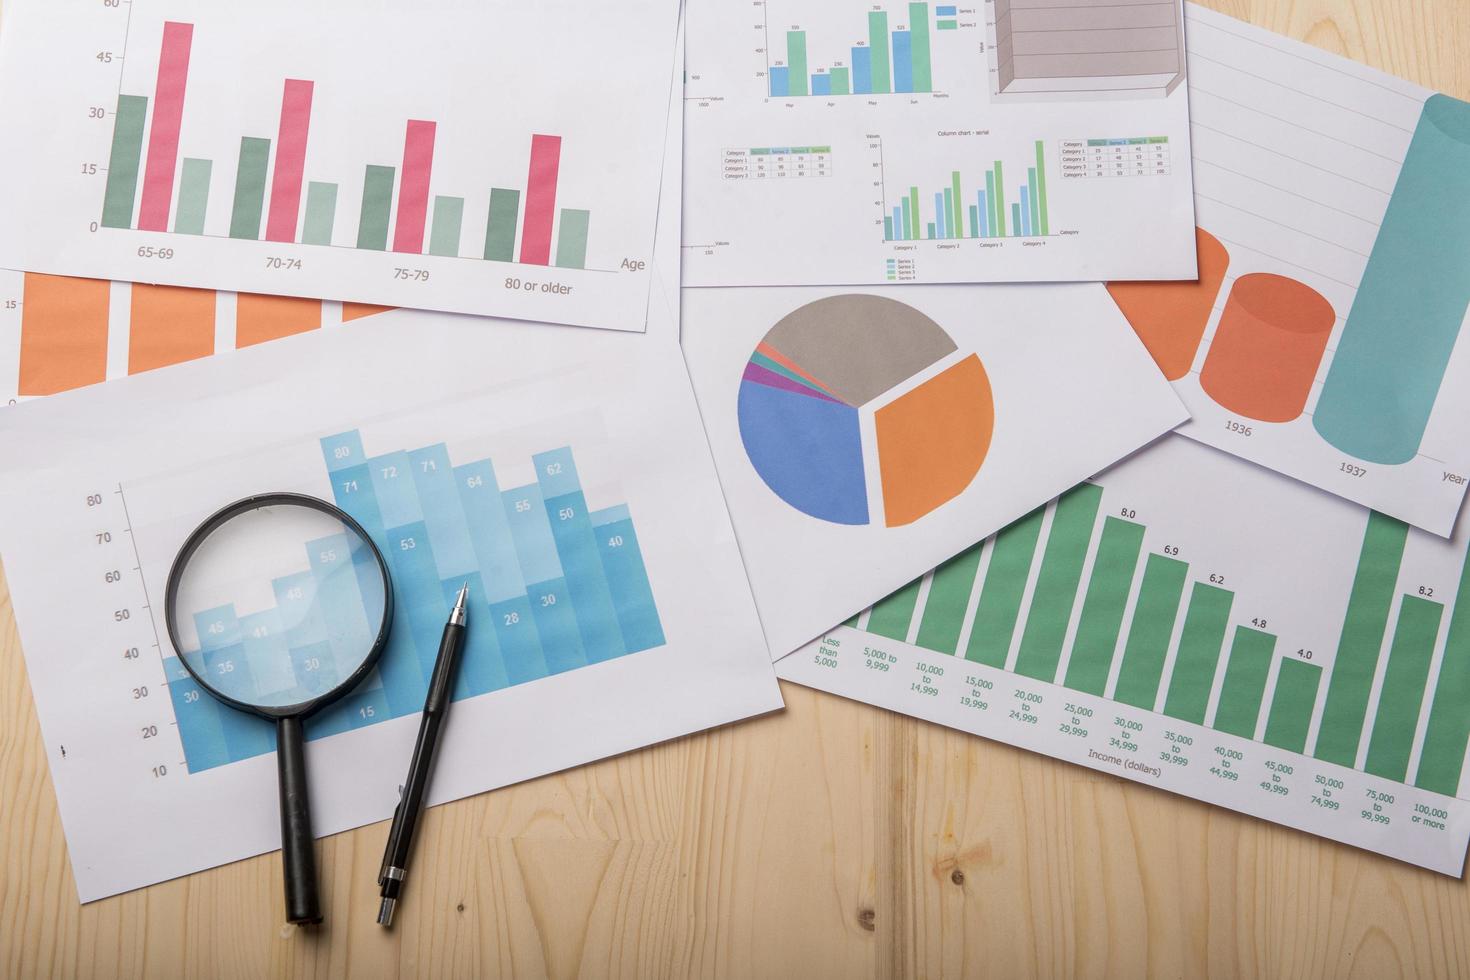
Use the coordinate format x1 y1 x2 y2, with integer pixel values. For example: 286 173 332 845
684 285 1185 657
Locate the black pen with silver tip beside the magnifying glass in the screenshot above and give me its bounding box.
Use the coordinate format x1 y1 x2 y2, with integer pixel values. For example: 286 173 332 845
378 583 469 926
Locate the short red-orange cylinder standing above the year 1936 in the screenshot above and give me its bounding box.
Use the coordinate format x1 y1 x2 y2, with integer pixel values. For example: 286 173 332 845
1200 272 1338 422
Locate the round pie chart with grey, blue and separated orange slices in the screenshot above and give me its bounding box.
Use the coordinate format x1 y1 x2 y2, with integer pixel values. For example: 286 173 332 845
738 294 995 527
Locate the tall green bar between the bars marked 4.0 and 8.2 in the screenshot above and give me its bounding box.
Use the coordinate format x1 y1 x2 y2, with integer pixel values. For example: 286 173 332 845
1316 511 1408 768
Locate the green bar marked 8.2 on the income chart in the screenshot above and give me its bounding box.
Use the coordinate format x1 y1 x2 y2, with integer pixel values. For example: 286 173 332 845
1363 595 1446 782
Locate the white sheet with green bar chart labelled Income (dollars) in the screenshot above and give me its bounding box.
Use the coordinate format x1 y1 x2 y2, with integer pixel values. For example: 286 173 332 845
776 436 1470 877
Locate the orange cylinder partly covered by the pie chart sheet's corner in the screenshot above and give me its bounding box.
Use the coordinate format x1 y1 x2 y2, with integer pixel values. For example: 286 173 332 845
1107 228 1230 381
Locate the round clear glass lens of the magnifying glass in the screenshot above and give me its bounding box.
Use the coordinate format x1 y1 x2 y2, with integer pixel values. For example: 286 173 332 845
169 502 388 714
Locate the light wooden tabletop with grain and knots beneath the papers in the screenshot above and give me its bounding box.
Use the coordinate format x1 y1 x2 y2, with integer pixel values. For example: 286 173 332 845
0 0 1470 980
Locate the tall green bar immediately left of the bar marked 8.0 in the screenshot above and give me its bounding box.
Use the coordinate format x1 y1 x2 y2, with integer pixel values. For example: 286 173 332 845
1016 483 1103 683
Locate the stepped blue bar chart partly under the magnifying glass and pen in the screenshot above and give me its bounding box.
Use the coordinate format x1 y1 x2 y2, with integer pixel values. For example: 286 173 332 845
165 430 664 773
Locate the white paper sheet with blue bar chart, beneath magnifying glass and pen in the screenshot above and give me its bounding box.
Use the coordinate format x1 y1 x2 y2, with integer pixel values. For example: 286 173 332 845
0 311 781 901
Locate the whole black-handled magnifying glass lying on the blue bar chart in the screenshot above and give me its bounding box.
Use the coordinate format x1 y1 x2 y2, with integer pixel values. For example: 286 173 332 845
165 494 392 923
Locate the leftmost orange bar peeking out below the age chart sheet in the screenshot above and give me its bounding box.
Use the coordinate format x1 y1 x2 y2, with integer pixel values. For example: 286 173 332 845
18 272 112 395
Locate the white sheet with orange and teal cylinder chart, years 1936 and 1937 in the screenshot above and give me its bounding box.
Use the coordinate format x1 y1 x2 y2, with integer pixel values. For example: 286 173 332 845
1110 6 1470 536
